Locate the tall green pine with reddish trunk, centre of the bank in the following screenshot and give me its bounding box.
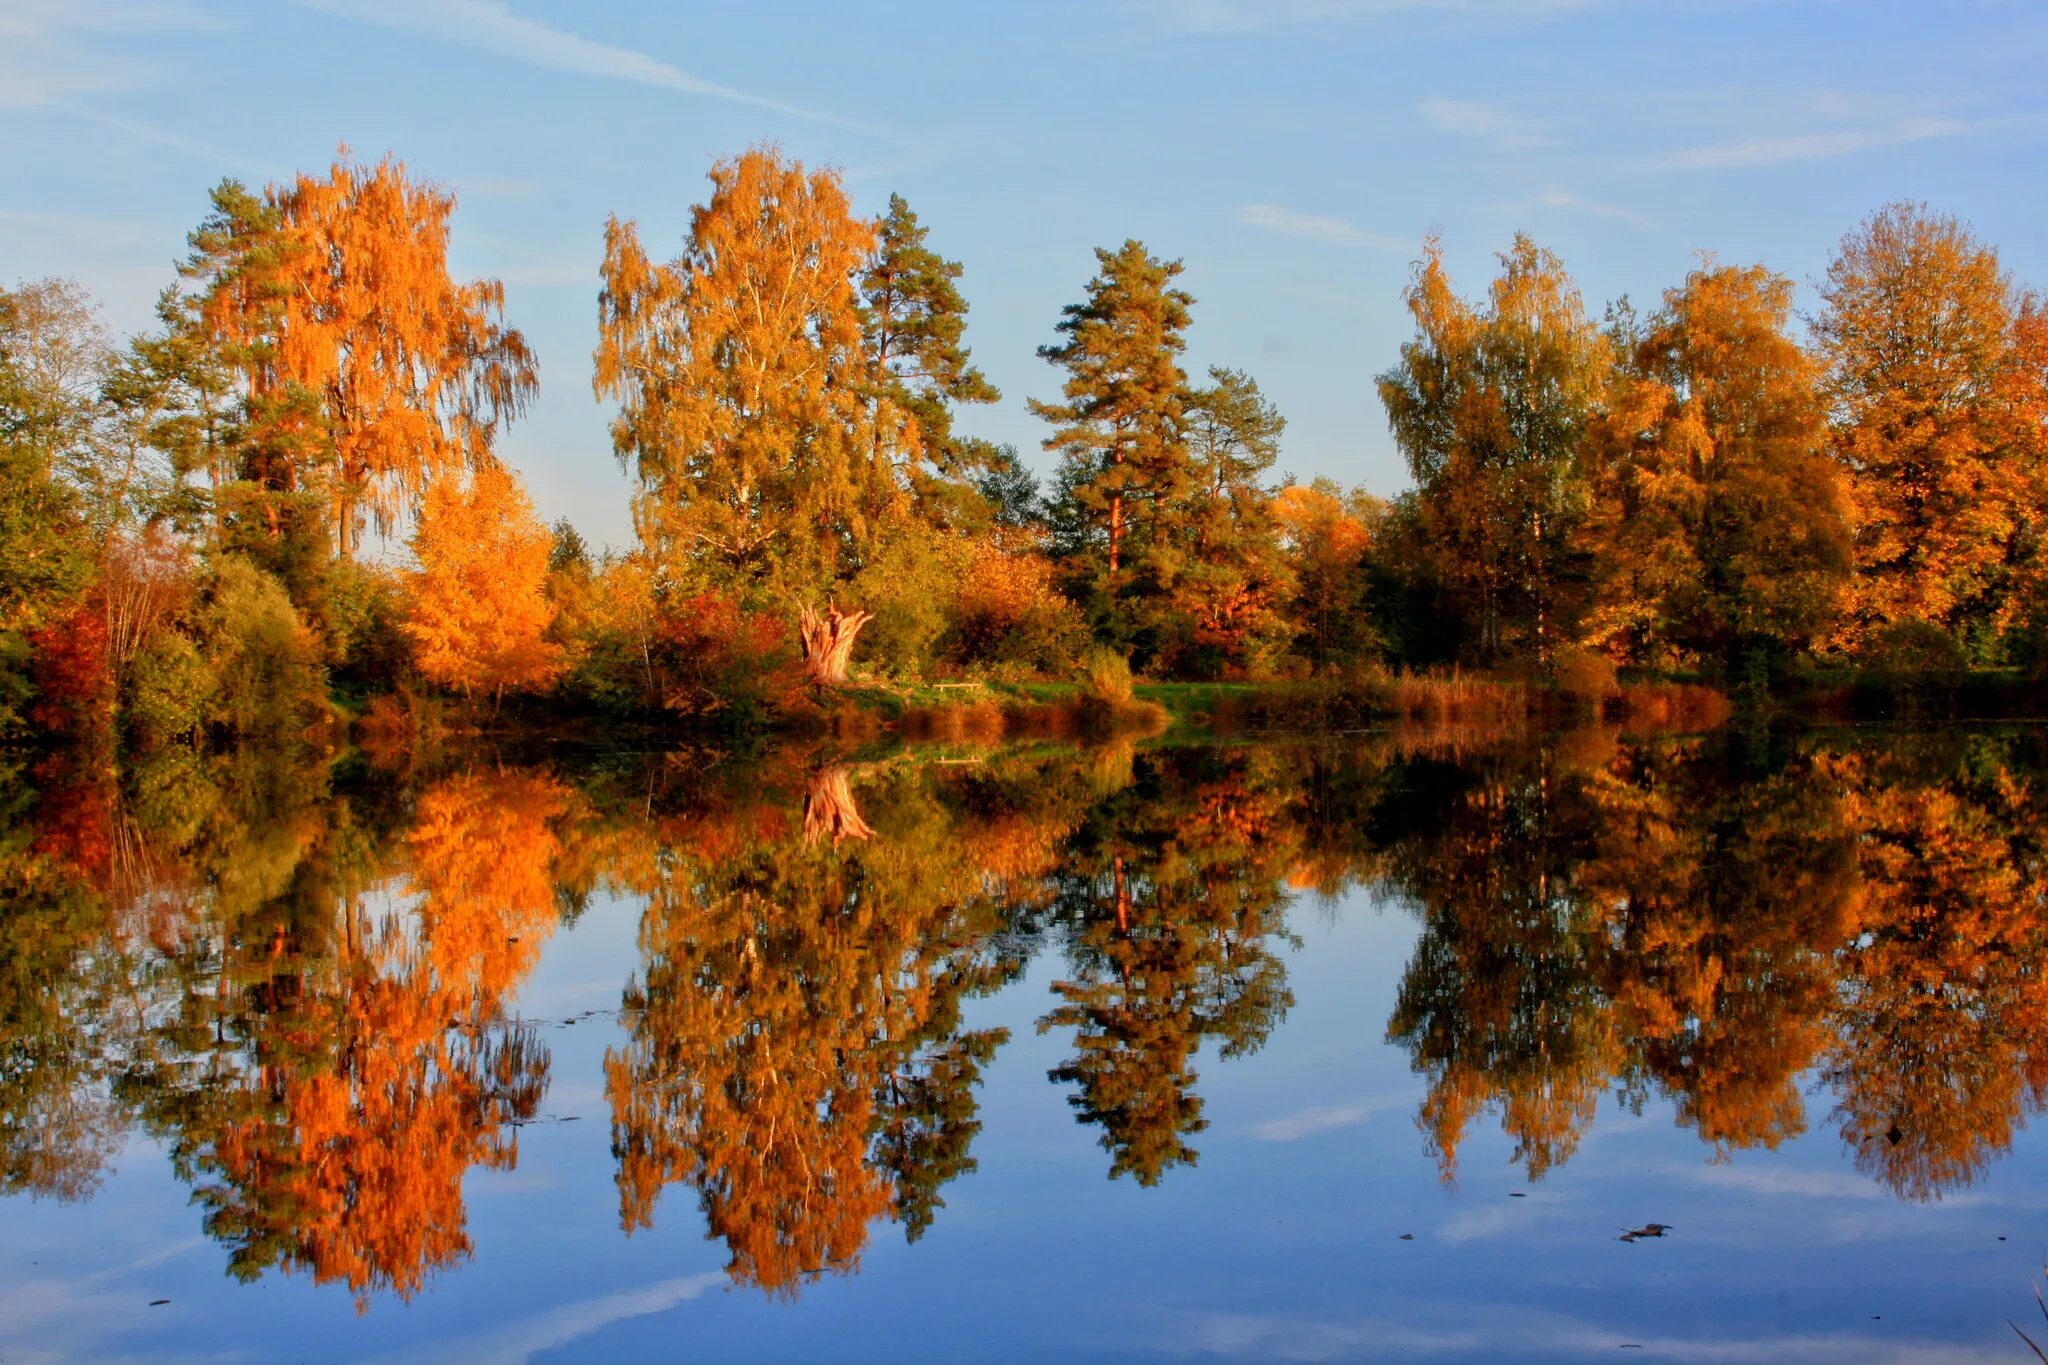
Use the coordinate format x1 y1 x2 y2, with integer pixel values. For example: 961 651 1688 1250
1030 241 1194 630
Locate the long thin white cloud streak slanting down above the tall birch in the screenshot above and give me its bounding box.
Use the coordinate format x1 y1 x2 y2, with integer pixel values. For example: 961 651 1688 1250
293 0 856 127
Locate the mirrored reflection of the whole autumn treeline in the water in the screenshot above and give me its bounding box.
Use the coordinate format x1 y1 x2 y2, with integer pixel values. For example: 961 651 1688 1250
12 731 2048 1300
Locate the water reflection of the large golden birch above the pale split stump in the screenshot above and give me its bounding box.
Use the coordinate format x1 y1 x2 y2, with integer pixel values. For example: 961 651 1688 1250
604 772 1020 1293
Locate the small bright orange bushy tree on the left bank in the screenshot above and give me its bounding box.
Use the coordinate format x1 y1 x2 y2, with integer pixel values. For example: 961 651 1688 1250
406 463 563 704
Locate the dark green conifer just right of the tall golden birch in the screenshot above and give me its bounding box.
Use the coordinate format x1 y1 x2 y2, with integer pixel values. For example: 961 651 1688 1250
860 194 1001 522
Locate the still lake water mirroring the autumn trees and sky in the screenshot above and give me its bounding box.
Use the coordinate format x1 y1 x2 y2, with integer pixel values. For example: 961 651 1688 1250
0 731 2048 1363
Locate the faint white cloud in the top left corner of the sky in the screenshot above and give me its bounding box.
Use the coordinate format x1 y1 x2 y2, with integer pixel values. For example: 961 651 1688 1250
0 0 219 108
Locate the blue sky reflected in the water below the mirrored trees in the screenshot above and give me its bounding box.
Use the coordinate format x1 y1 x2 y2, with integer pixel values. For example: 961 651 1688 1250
0 749 2048 1365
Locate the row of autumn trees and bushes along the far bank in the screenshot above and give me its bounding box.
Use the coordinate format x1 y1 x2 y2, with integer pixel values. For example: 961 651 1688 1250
0 149 2048 749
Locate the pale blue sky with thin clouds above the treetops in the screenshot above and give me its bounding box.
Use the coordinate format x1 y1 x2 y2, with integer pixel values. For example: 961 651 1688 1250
0 0 2048 544
